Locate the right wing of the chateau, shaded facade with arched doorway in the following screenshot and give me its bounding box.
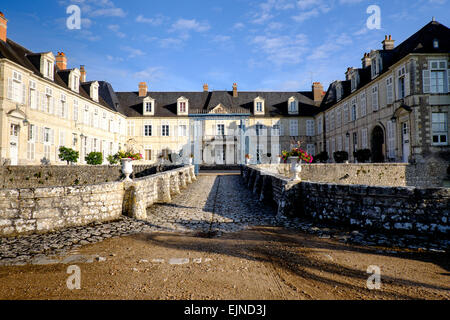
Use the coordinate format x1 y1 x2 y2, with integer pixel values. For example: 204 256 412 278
316 19 450 162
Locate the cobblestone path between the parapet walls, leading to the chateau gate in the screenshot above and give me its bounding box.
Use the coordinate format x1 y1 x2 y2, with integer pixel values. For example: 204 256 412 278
147 175 282 235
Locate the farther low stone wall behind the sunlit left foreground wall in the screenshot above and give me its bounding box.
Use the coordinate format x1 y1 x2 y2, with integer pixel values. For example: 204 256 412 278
0 165 180 189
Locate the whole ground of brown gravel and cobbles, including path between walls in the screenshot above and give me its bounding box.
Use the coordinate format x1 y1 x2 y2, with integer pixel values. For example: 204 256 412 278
0 173 450 300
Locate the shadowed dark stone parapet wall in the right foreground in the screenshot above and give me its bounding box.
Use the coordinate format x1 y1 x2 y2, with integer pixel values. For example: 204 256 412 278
241 166 450 238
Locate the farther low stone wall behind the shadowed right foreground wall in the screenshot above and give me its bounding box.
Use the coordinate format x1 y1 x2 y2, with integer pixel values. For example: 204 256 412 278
256 162 447 187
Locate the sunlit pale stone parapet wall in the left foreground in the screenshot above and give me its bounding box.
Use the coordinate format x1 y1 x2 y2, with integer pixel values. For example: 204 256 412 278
0 166 195 236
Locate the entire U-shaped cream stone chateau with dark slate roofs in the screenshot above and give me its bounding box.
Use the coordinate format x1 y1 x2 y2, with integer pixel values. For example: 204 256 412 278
0 13 450 165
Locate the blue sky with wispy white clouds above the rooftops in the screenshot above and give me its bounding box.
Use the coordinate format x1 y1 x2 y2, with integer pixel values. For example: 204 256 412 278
0 0 450 91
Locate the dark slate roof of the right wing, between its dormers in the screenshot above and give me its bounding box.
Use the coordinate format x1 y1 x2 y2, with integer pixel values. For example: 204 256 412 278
320 21 450 111
